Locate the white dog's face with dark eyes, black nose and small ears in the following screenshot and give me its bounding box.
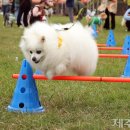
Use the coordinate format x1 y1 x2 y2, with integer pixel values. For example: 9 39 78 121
20 33 45 64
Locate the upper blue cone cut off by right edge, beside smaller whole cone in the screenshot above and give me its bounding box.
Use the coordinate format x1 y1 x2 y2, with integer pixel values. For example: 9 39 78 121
122 36 130 55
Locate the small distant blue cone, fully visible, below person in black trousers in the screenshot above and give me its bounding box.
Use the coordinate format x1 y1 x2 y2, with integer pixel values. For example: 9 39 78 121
106 30 116 47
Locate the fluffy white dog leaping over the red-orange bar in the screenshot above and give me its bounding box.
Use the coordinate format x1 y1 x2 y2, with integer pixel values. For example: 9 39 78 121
20 22 98 79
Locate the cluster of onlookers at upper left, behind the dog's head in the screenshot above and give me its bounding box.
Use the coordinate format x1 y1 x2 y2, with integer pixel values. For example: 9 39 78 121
1 0 54 27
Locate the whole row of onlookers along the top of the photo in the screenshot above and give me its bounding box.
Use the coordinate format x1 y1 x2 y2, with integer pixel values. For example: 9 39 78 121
0 0 130 31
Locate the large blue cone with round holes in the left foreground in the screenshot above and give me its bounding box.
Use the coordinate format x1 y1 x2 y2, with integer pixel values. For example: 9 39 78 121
8 60 44 113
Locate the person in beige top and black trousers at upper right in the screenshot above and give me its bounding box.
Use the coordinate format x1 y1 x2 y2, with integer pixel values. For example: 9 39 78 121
104 0 117 30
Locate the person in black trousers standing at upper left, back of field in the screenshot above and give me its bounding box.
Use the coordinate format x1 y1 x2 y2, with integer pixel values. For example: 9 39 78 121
17 0 31 27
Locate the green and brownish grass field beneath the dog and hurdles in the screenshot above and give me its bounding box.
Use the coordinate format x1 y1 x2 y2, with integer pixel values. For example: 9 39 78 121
0 16 130 130
